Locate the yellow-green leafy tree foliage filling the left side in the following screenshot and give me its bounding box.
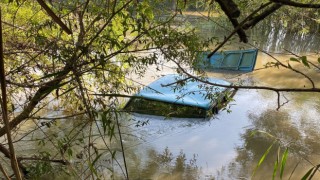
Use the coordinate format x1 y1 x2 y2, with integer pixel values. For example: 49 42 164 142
0 0 202 178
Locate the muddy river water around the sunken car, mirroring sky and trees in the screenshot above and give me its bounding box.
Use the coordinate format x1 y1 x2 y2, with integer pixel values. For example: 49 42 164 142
120 13 320 179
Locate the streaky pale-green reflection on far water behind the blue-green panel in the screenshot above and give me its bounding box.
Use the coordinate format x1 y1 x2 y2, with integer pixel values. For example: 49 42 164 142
190 13 320 54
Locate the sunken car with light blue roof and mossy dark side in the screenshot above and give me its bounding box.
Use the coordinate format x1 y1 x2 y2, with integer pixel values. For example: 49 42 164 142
124 74 235 118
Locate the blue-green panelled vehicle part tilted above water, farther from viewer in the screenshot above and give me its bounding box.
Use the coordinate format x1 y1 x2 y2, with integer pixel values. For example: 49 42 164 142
197 49 258 72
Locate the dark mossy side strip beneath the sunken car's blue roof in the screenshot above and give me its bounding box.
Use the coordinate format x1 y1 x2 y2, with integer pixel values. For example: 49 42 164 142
124 98 207 118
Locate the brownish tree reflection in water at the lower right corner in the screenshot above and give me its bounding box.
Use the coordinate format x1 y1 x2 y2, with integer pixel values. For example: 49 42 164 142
218 109 320 179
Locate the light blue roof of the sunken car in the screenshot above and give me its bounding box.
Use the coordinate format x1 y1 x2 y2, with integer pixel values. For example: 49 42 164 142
135 74 231 110
